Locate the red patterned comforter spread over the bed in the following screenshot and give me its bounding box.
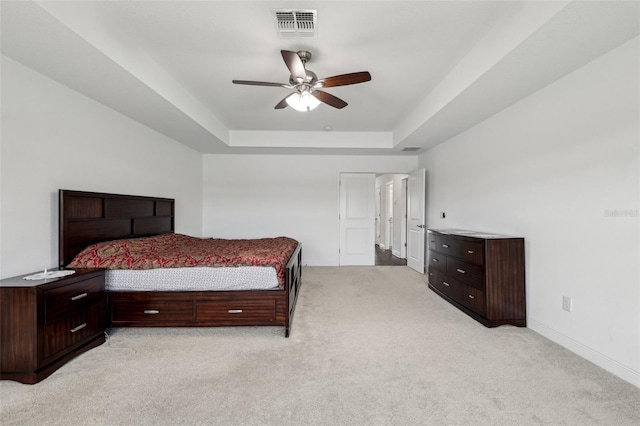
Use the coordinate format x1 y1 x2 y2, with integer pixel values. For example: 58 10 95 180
67 234 298 288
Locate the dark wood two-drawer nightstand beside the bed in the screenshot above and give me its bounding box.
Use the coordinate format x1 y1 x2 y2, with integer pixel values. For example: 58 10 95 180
0 269 107 384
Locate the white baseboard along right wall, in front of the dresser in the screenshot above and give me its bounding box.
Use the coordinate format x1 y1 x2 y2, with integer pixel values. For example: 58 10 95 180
527 318 640 388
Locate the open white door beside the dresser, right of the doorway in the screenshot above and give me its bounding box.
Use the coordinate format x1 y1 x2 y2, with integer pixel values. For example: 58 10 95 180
407 169 427 274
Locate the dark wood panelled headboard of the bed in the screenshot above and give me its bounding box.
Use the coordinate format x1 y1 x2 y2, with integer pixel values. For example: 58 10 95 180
58 189 175 268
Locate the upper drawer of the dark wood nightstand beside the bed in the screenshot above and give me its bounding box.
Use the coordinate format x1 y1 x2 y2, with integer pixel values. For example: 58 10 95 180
44 275 104 324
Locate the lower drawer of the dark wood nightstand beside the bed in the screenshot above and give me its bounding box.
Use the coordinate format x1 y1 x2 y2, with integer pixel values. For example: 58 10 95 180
43 305 104 358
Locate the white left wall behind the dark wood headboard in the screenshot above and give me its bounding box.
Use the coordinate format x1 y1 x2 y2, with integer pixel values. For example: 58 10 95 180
0 56 202 278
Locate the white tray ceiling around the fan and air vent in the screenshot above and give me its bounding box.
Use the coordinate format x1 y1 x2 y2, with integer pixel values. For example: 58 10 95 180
0 0 640 155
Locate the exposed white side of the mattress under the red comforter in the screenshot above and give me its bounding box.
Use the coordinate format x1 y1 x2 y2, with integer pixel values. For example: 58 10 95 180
105 266 279 291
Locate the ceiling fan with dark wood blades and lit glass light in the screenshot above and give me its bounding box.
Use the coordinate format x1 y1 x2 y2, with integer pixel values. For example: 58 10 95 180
233 50 371 111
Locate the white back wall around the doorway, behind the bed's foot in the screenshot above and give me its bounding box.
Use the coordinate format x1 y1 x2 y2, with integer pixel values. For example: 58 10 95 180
203 155 418 265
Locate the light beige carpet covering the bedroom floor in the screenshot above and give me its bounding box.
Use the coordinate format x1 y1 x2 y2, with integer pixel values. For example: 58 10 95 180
0 266 640 425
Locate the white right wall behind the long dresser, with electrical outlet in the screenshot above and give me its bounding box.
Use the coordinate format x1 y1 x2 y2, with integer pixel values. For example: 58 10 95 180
419 38 640 386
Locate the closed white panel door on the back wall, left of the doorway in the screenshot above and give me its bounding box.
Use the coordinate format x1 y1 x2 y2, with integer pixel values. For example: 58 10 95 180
340 173 376 265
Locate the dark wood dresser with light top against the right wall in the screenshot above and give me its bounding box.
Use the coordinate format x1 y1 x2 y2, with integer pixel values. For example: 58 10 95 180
427 229 527 327
